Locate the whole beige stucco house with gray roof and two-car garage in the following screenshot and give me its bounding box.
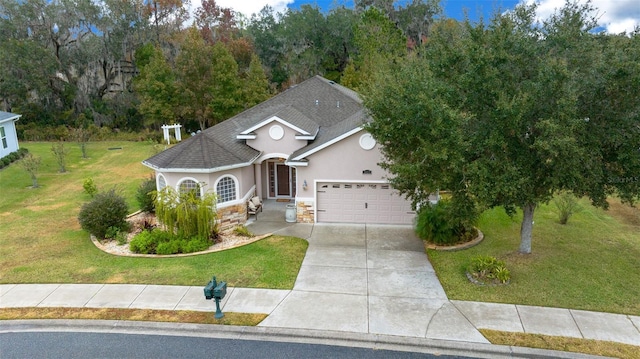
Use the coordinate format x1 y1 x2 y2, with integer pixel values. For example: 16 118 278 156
142 76 415 229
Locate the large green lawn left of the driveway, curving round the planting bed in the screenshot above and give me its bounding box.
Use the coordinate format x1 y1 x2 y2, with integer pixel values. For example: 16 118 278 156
0 142 307 289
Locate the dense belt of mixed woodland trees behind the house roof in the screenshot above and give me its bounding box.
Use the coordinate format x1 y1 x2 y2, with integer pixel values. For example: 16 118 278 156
0 0 440 133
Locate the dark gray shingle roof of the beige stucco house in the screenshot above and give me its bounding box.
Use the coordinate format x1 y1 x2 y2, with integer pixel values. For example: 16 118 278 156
143 76 366 172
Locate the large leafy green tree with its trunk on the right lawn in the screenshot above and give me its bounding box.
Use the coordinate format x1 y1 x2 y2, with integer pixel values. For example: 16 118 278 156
362 3 640 253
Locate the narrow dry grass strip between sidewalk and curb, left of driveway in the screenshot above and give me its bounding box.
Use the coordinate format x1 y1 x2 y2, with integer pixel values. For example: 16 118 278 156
0 308 267 326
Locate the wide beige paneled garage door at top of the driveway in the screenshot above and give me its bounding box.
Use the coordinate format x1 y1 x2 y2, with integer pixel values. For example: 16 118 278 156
316 183 415 224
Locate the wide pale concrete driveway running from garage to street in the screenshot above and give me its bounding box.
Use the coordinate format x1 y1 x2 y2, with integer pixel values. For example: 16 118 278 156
255 224 486 342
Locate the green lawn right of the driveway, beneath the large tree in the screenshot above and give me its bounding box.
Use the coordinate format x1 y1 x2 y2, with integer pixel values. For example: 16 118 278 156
427 199 640 315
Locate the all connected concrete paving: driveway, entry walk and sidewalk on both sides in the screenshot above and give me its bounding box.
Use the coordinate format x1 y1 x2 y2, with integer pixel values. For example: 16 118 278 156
0 219 640 352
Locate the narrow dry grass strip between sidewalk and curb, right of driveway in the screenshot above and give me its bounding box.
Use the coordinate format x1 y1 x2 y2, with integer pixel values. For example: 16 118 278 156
480 329 640 359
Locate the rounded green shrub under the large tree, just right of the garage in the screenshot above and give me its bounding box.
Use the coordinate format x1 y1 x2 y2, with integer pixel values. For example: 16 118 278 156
416 199 477 245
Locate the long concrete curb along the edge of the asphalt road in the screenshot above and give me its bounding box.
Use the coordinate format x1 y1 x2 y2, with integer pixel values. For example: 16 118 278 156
0 319 601 359
